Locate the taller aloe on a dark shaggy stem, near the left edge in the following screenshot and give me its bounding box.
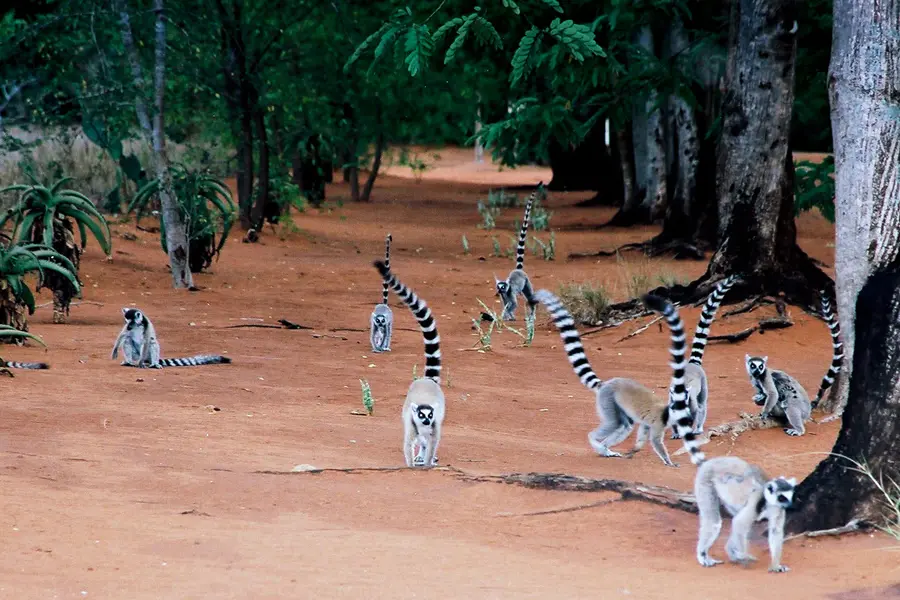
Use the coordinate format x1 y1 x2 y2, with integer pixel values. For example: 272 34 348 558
0 177 112 323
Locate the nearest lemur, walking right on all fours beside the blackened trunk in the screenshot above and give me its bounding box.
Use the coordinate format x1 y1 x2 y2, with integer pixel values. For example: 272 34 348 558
643 295 797 573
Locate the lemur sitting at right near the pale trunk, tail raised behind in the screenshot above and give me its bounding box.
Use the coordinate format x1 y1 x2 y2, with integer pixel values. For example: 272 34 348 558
744 294 844 436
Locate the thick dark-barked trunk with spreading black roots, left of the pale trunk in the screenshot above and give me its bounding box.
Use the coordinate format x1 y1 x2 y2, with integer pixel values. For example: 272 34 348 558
658 0 833 312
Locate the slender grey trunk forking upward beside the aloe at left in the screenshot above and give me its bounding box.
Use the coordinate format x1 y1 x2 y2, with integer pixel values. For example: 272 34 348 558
113 0 194 288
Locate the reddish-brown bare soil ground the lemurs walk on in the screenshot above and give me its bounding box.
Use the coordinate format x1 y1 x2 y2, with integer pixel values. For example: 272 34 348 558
0 150 900 600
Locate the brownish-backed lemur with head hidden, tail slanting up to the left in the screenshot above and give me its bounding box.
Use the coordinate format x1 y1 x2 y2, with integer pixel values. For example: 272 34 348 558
535 290 684 467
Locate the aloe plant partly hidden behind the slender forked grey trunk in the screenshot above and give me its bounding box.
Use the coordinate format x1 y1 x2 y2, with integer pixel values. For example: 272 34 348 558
128 167 235 273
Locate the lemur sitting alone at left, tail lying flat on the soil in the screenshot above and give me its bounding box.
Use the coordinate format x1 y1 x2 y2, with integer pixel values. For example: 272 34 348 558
110 308 231 369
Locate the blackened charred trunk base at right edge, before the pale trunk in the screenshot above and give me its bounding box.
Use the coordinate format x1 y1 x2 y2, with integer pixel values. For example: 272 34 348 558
788 264 900 532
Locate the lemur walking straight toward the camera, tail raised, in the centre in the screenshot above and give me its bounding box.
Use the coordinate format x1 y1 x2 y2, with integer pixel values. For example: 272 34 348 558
375 260 446 467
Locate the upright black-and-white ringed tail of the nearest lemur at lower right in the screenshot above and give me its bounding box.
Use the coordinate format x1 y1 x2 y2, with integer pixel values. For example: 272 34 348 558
642 294 706 465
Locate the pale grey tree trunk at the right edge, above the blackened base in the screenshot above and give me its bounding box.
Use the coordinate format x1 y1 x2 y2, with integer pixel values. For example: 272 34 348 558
820 0 900 412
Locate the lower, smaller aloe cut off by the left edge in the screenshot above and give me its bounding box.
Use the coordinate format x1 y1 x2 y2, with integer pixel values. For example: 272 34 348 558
0 244 81 338
